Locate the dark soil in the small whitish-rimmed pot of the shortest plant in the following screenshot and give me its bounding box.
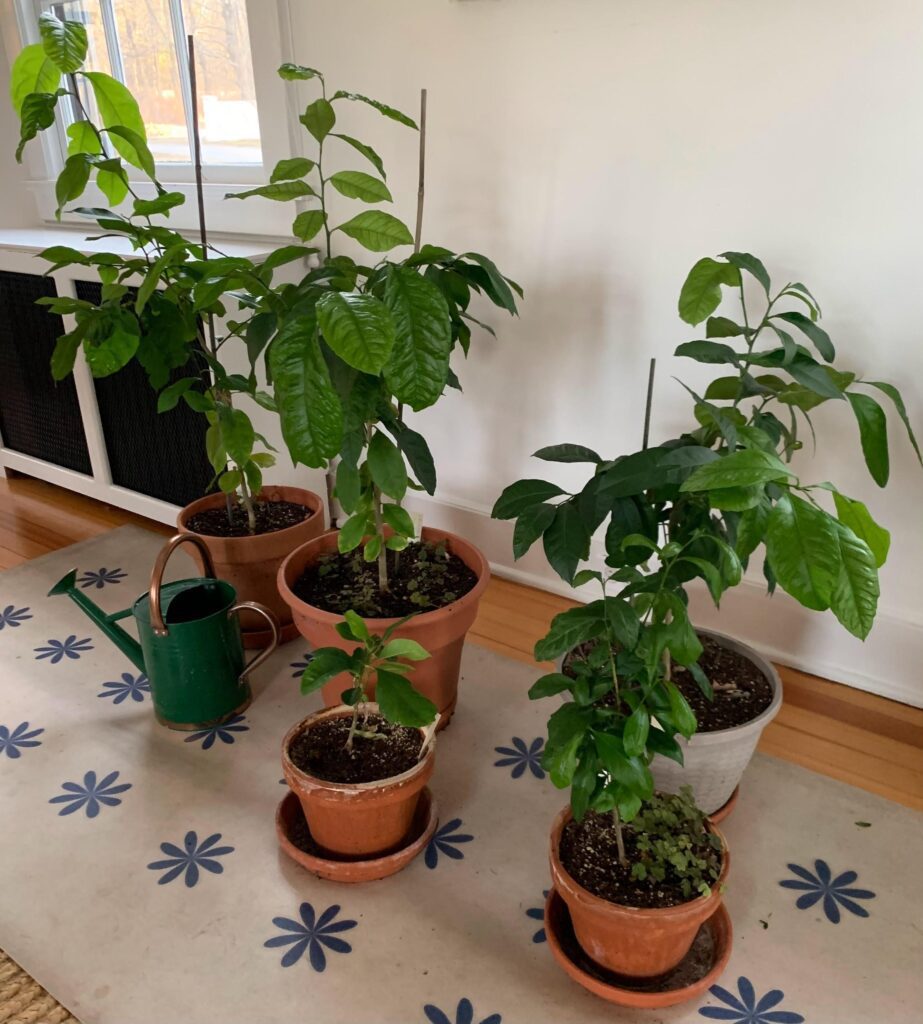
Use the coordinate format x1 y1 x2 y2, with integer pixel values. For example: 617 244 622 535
289 713 423 782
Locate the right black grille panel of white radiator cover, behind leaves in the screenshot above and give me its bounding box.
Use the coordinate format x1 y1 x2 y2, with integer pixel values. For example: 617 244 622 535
77 281 213 505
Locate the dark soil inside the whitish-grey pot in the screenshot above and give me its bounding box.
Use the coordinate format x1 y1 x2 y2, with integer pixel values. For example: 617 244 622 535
673 636 772 732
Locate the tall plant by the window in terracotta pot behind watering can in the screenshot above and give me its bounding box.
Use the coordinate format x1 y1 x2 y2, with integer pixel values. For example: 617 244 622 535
11 13 339 646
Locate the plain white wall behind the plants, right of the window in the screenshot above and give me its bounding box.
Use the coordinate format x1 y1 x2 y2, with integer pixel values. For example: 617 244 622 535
292 0 923 703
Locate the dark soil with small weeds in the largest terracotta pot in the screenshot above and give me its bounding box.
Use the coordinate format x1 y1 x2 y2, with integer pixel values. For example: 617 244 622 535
292 541 477 618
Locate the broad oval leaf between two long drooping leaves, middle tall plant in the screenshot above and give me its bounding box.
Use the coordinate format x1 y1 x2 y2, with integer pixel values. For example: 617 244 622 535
317 292 394 374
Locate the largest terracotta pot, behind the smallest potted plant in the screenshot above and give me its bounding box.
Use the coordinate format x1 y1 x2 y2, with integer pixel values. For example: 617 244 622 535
279 526 491 729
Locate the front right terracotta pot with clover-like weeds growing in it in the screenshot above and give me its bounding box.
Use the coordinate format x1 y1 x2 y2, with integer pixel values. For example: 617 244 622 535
551 807 729 978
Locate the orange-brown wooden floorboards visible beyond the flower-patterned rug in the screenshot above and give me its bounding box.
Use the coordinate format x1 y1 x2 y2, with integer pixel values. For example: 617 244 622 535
0 477 923 810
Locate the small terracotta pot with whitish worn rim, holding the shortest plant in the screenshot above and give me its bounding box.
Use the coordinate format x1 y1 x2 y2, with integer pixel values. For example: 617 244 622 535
282 705 433 860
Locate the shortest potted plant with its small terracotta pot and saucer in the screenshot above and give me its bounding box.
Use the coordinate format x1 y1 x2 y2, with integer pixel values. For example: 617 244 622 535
278 609 438 882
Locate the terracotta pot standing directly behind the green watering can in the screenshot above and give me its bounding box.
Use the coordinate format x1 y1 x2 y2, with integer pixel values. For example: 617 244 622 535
176 485 324 647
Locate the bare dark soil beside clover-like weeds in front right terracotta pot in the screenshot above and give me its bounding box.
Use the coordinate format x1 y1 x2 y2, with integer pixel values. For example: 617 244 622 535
559 811 713 908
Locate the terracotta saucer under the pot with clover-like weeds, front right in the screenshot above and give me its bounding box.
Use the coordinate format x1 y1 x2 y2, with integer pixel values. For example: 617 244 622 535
545 889 733 1010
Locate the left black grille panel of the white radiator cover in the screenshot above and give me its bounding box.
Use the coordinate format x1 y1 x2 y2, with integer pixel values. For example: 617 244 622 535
0 270 92 475
